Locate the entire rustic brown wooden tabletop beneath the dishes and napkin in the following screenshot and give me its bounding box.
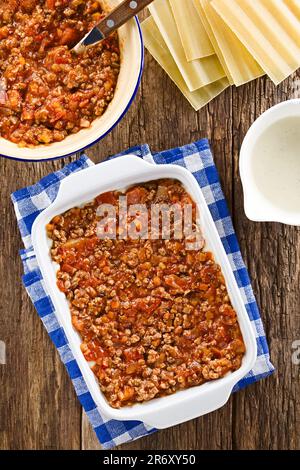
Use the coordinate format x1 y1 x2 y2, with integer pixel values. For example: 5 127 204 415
0 31 300 450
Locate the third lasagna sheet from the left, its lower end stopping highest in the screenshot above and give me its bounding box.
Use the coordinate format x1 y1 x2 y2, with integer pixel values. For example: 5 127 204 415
170 0 215 61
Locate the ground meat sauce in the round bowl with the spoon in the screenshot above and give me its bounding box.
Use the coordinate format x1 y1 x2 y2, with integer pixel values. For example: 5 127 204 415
0 0 120 147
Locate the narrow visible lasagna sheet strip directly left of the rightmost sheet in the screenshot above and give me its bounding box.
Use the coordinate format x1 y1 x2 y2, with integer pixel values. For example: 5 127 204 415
197 0 265 86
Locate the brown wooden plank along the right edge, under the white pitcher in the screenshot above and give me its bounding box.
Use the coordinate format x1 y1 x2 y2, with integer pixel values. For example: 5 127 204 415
233 72 300 449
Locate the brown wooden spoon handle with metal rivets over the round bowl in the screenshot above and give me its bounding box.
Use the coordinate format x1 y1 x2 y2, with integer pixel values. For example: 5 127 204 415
97 0 153 38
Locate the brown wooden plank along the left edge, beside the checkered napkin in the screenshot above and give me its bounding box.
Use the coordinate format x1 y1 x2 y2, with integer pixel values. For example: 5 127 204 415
0 159 81 449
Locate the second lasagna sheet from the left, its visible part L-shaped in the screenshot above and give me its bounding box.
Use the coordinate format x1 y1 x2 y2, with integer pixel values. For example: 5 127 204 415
149 0 225 91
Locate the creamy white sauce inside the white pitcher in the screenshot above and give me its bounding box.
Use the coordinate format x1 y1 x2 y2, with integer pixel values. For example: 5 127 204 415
251 116 300 212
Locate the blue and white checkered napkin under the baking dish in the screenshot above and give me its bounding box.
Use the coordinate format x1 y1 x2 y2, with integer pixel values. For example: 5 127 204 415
12 140 274 449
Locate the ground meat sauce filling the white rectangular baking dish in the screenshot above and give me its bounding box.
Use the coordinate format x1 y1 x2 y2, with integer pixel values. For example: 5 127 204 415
47 179 245 408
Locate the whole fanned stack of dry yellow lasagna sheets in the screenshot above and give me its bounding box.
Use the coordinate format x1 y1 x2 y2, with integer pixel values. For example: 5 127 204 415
142 0 300 110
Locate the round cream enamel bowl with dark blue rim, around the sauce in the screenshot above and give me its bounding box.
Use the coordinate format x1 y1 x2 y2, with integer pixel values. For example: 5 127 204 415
0 0 144 161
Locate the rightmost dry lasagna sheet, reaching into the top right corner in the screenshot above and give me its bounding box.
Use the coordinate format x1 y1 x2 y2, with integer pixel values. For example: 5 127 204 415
211 0 300 85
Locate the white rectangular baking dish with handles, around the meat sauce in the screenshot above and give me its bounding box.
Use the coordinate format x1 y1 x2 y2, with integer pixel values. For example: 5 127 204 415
32 155 257 429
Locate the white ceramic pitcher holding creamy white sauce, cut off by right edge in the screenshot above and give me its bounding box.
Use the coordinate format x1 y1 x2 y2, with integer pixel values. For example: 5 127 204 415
240 99 300 225
